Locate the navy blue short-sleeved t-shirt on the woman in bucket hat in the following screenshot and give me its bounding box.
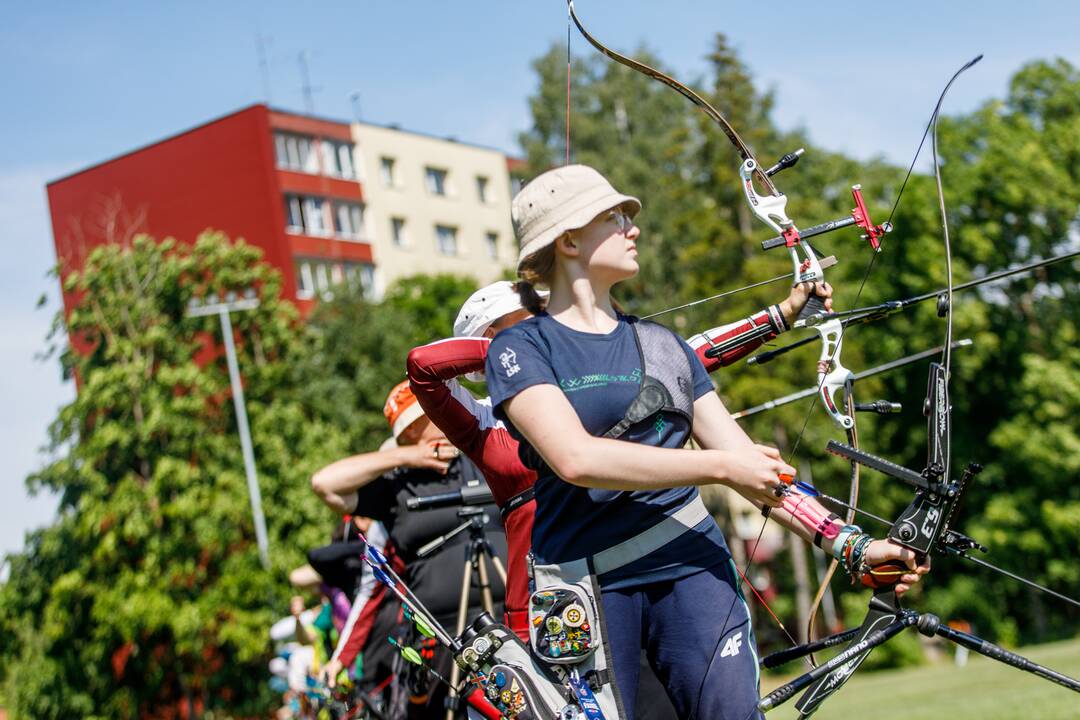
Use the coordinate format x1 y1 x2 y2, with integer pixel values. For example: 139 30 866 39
486 313 730 589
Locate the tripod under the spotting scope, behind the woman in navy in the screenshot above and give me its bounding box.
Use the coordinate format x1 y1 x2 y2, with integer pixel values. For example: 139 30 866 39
417 506 507 720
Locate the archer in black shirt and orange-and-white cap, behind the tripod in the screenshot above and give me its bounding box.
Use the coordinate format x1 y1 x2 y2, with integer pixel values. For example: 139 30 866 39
311 381 507 712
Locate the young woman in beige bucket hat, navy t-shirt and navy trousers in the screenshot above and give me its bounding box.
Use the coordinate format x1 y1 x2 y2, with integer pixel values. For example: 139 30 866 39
486 165 928 720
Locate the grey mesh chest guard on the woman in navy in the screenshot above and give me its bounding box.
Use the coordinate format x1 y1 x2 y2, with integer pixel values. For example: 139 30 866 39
600 320 693 438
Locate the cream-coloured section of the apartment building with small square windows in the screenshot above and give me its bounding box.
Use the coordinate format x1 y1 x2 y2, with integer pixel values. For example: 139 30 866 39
352 123 517 297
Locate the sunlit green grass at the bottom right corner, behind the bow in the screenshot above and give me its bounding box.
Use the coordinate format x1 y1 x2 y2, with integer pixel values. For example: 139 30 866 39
762 639 1080 720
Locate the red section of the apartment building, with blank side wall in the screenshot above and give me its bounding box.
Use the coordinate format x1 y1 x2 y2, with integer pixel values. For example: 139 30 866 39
48 105 373 311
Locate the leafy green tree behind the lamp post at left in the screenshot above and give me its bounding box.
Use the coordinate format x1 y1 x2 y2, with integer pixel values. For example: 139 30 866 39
0 233 345 718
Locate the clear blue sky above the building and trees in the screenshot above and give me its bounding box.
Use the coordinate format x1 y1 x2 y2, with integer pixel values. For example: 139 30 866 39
0 0 1080 553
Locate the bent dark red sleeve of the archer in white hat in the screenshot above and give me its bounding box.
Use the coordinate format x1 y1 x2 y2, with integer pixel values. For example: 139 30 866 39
406 338 494 457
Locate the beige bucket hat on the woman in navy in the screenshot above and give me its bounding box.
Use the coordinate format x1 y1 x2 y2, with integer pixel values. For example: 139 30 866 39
510 165 642 264
